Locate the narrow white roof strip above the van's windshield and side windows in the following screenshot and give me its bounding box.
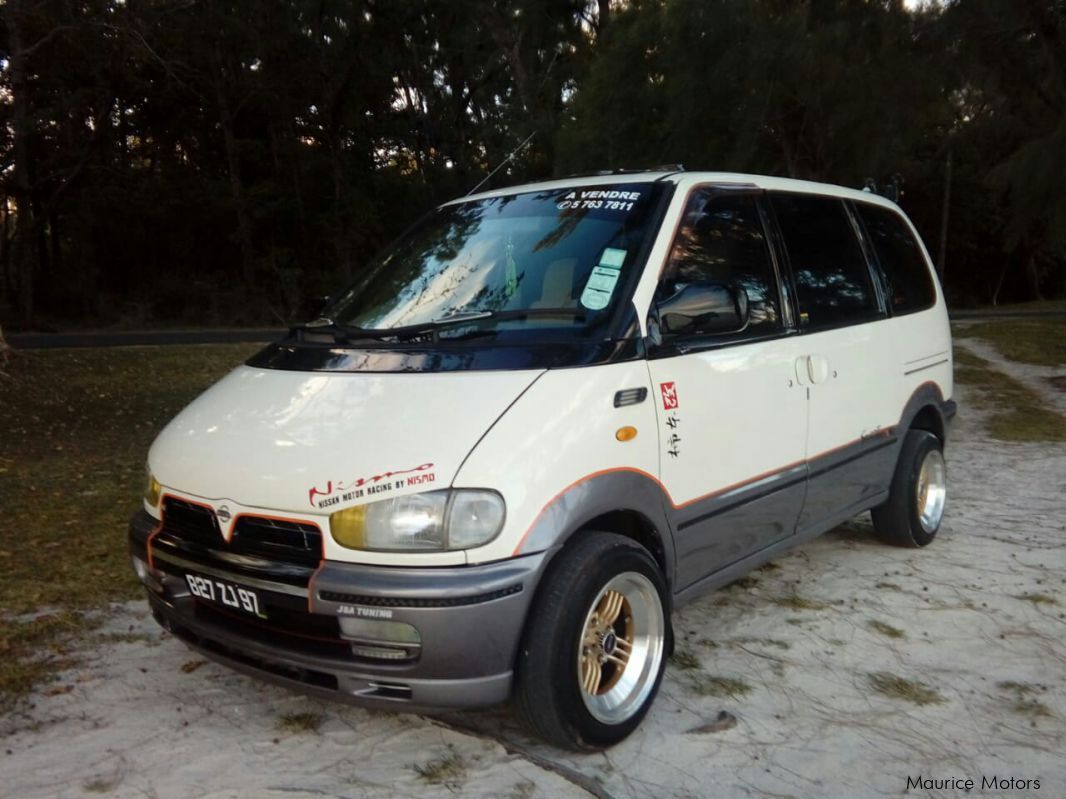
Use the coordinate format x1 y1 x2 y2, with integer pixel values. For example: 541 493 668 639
454 170 898 209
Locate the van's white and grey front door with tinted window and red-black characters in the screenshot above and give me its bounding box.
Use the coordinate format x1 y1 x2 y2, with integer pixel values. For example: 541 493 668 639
648 189 807 589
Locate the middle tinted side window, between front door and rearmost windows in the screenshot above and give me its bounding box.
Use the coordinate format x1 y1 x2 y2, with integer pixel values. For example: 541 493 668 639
771 194 881 329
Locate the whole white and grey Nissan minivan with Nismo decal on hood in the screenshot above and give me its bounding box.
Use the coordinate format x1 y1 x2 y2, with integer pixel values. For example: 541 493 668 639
130 172 955 748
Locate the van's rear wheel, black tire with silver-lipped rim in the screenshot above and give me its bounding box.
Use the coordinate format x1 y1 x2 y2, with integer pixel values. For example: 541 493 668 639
870 430 948 547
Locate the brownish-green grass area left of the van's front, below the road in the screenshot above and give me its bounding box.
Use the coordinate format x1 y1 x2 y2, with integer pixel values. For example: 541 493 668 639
0 344 260 703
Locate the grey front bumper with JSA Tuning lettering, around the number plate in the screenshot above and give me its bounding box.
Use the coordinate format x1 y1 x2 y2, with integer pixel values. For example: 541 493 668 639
130 510 547 711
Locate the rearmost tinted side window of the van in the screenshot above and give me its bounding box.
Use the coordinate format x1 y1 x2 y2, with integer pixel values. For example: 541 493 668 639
855 202 936 314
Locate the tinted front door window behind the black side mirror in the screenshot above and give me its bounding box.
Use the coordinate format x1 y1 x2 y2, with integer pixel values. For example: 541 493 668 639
657 190 781 335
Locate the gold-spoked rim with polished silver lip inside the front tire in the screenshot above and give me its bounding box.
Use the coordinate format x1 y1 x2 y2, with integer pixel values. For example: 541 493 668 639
577 572 666 723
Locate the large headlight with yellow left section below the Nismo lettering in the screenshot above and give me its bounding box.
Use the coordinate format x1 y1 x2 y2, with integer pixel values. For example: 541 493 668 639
329 489 504 552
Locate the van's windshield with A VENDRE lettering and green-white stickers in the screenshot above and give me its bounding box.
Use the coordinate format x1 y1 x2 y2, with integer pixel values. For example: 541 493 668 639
324 183 661 330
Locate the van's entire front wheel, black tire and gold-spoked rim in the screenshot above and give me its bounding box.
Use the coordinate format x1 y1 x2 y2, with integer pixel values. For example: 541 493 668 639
515 533 669 750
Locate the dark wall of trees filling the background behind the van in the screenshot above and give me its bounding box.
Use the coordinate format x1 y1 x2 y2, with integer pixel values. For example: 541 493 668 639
0 0 1066 329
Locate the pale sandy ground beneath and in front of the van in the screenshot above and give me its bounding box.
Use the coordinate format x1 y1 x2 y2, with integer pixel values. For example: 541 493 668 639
0 349 1066 799
